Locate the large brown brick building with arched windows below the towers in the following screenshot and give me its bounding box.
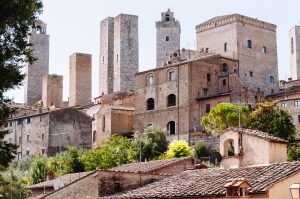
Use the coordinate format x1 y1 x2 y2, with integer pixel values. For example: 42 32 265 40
135 55 262 140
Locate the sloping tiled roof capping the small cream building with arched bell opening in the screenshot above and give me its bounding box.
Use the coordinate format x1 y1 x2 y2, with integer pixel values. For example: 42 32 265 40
222 128 288 144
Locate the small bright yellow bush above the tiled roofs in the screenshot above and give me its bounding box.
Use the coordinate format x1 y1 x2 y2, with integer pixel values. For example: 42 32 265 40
166 140 192 158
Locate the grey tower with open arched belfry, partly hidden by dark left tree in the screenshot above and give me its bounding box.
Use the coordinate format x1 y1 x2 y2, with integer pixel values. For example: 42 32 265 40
24 20 49 104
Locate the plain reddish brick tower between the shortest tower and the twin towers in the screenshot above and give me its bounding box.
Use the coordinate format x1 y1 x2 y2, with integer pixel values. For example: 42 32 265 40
69 53 92 106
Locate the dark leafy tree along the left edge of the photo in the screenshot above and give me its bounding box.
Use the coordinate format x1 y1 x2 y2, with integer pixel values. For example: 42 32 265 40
0 0 43 167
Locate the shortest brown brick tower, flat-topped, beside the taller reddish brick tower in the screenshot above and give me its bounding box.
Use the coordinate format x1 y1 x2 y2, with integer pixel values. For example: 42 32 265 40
43 74 63 108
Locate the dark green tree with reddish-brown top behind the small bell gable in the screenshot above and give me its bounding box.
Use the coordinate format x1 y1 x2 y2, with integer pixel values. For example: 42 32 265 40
247 101 296 141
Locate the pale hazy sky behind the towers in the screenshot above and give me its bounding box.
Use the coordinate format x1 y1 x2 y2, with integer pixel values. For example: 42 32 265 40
8 0 300 102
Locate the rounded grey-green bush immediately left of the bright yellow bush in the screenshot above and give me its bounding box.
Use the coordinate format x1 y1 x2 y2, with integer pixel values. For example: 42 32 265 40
135 127 169 161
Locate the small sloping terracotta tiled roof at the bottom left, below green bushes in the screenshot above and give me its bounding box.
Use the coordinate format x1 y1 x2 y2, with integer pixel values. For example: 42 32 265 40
28 172 91 189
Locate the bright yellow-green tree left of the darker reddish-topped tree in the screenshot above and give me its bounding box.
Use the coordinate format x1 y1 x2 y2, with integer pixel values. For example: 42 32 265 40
201 103 250 133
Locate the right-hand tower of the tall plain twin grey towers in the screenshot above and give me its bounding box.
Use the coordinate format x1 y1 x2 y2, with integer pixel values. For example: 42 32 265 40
113 14 139 92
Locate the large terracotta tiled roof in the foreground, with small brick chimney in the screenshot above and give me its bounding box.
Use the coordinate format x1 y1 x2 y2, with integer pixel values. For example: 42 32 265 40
104 162 300 199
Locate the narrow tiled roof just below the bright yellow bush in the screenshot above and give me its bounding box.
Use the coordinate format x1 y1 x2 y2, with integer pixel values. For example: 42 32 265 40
109 157 192 173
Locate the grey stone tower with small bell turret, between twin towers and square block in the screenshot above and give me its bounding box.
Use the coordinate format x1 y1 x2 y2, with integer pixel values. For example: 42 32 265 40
156 9 181 68
